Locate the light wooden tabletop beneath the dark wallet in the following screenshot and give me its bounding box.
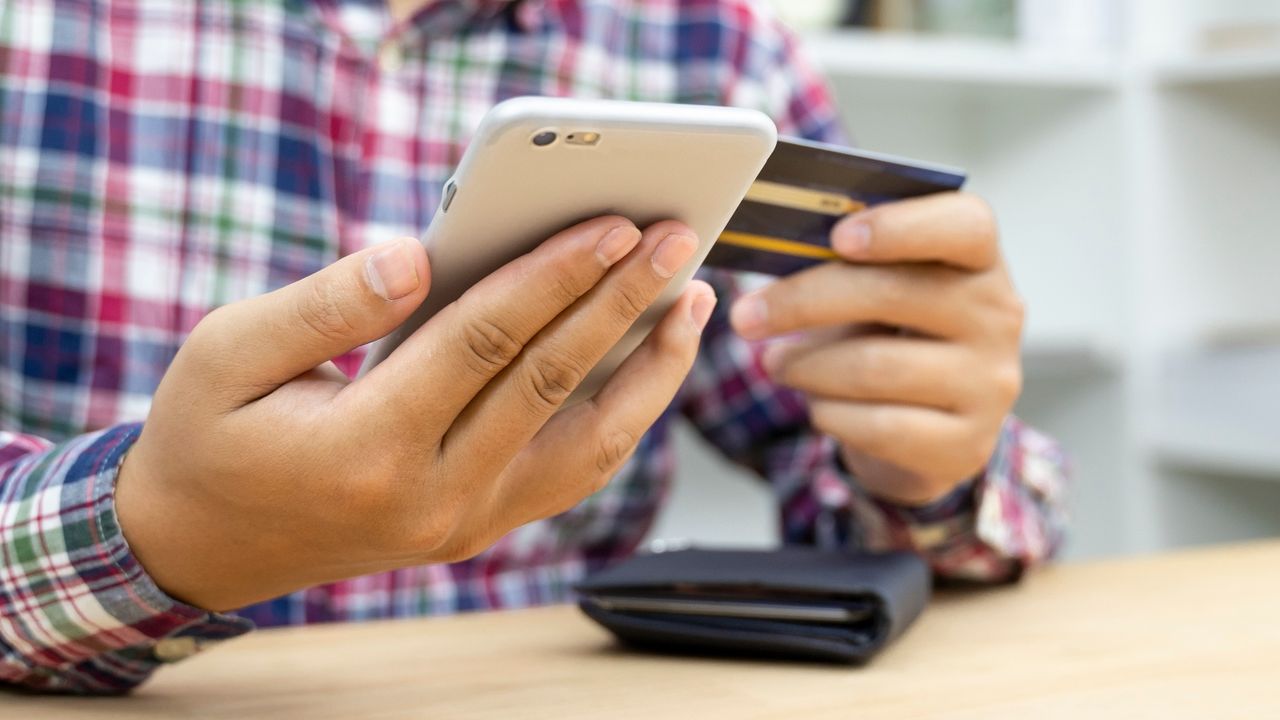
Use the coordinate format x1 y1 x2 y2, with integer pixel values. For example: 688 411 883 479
10 542 1280 720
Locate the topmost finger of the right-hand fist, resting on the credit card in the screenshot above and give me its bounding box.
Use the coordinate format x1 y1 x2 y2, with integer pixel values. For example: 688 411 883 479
831 192 1000 270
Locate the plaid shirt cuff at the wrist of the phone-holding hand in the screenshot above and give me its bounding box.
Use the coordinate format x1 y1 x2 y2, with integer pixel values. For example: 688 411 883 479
0 424 252 693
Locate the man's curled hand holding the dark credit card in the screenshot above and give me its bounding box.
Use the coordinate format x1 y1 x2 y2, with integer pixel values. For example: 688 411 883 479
731 193 1023 505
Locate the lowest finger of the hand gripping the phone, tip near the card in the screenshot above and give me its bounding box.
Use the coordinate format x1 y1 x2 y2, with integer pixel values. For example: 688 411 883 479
488 281 716 523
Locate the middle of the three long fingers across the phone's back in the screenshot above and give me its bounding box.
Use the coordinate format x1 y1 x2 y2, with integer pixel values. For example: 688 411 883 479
445 222 698 469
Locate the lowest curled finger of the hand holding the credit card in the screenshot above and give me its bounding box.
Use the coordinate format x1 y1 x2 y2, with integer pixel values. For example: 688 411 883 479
809 400 998 487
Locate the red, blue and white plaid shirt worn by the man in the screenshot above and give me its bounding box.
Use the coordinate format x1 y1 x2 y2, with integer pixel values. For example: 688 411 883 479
0 0 1065 692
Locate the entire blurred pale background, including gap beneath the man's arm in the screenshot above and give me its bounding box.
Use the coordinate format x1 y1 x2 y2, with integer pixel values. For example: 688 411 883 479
652 0 1280 559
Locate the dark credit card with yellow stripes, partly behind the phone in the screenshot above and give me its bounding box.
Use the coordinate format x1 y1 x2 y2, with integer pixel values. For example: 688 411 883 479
705 138 965 275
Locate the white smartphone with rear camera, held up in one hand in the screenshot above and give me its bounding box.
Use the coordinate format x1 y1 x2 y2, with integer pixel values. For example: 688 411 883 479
361 97 777 402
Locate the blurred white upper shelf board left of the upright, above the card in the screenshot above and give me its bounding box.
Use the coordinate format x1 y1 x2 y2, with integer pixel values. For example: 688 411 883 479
804 31 1117 91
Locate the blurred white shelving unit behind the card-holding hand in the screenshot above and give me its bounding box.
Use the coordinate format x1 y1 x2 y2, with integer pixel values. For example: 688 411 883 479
806 0 1280 557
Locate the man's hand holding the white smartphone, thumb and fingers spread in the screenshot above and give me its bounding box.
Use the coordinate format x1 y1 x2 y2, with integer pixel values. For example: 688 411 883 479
116 217 716 610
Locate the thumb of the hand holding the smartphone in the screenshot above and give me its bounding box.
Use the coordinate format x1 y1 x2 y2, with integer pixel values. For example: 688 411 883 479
193 237 430 388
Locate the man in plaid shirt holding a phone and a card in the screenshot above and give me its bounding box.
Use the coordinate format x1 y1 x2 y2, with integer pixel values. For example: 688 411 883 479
0 0 1062 693
